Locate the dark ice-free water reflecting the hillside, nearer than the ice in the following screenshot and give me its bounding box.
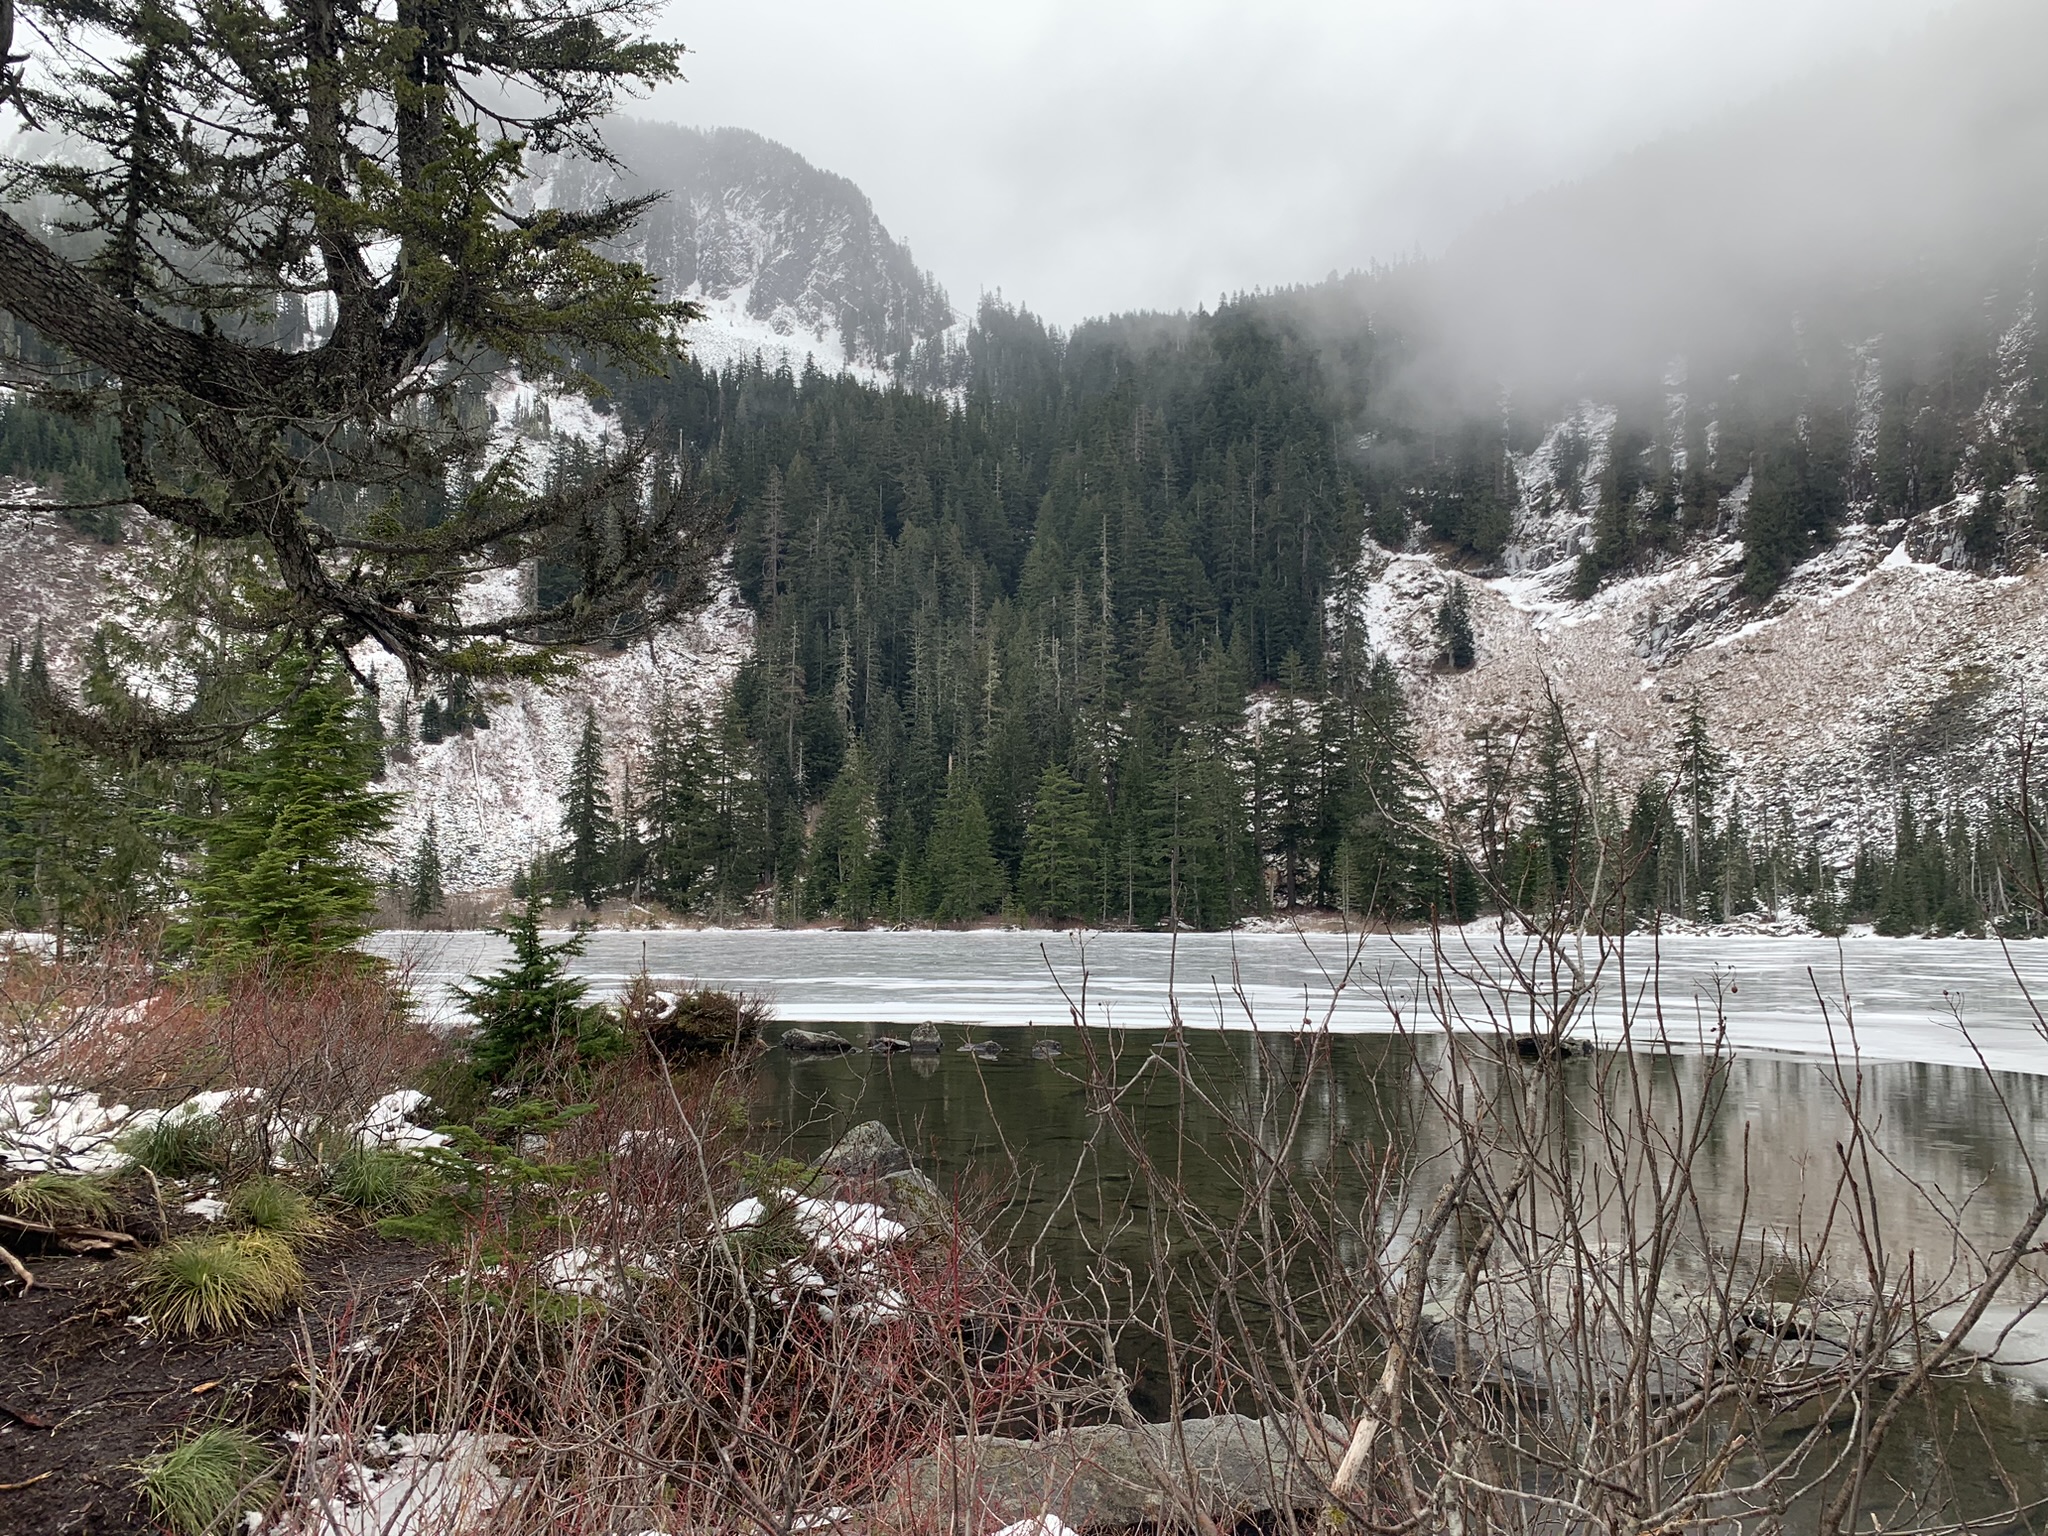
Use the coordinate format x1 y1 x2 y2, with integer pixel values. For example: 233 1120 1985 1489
756 1028 2048 1530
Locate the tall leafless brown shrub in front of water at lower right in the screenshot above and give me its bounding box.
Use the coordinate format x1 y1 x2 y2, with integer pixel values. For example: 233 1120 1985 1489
1040 918 2048 1532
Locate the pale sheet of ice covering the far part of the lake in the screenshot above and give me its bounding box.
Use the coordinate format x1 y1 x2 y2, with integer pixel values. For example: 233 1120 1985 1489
369 928 2048 1073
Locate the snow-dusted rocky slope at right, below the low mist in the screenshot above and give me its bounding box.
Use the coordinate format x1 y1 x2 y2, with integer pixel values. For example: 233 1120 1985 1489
1360 498 2048 868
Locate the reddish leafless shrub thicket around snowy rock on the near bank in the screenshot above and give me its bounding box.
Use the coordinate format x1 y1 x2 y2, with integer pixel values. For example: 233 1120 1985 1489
293 1057 1071 1534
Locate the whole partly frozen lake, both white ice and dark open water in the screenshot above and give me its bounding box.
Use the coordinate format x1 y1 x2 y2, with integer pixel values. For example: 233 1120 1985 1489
371 930 2048 1530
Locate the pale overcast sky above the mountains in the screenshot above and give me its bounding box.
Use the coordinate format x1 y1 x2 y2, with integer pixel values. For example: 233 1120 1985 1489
635 0 1946 324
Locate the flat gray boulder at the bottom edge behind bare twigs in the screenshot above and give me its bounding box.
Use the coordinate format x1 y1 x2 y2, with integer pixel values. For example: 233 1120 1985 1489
897 1413 1346 1532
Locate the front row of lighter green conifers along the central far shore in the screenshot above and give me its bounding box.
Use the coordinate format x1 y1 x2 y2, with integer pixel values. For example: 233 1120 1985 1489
522 629 1479 928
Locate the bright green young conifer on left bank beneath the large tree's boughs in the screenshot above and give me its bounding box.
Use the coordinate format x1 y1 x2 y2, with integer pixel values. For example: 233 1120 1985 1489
176 659 395 963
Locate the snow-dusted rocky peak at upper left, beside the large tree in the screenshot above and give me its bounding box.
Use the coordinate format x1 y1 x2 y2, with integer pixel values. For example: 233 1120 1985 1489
528 119 956 381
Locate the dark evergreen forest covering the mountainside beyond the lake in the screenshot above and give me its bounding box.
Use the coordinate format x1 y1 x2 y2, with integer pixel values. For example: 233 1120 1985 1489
0 250 2048 932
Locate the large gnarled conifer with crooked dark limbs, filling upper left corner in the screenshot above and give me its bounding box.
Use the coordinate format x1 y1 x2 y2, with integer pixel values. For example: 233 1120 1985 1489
0 0 723 692
